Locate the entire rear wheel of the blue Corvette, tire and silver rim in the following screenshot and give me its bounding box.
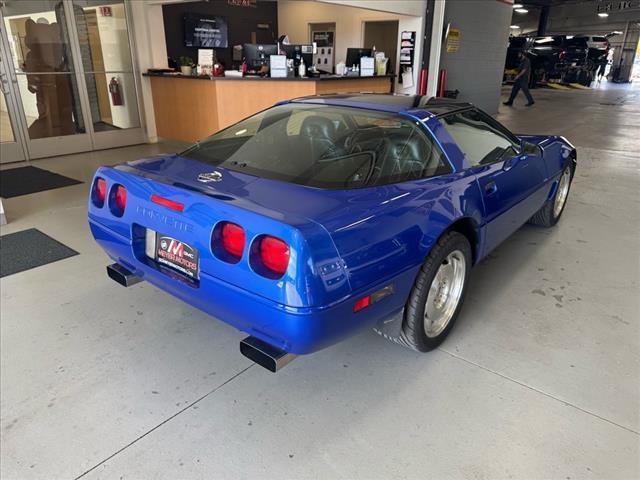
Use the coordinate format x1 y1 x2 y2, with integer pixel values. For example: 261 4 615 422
401 232 472 352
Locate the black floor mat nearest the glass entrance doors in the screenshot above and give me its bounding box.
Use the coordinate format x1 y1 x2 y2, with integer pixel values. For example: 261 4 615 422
0 166 82 198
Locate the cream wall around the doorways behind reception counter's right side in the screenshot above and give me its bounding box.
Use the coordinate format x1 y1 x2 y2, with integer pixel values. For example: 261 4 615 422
278 0 426 93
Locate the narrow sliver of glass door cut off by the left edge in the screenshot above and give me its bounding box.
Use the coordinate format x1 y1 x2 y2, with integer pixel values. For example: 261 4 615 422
0 42 26 163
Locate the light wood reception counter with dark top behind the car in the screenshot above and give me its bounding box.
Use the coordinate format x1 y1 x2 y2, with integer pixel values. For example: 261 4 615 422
144 74 393 142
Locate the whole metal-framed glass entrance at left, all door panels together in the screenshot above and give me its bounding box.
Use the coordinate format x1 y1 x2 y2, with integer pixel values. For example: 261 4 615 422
0 0 144 161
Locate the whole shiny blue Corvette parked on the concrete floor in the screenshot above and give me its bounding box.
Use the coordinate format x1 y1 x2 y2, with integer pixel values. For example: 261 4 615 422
89 94 576 371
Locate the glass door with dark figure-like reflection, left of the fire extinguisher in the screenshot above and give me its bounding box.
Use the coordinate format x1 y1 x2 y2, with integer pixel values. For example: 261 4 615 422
0 0 92 158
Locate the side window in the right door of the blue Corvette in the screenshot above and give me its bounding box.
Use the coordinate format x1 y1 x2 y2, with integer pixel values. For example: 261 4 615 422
440 109 519 167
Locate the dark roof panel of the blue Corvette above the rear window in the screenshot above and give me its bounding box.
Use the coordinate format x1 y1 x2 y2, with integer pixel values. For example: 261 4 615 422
291 93 473 116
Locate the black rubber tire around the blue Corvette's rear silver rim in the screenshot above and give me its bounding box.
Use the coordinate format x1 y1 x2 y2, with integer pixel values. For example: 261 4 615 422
400 232 472 352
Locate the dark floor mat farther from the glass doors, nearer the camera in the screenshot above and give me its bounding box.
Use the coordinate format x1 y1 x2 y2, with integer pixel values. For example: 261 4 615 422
0 228 78 278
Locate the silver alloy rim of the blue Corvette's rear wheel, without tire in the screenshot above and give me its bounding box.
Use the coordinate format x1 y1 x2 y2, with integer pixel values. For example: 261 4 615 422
424 250 467 338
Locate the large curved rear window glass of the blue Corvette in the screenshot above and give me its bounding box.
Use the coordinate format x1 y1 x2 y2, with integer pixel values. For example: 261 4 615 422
181 103 451 189
